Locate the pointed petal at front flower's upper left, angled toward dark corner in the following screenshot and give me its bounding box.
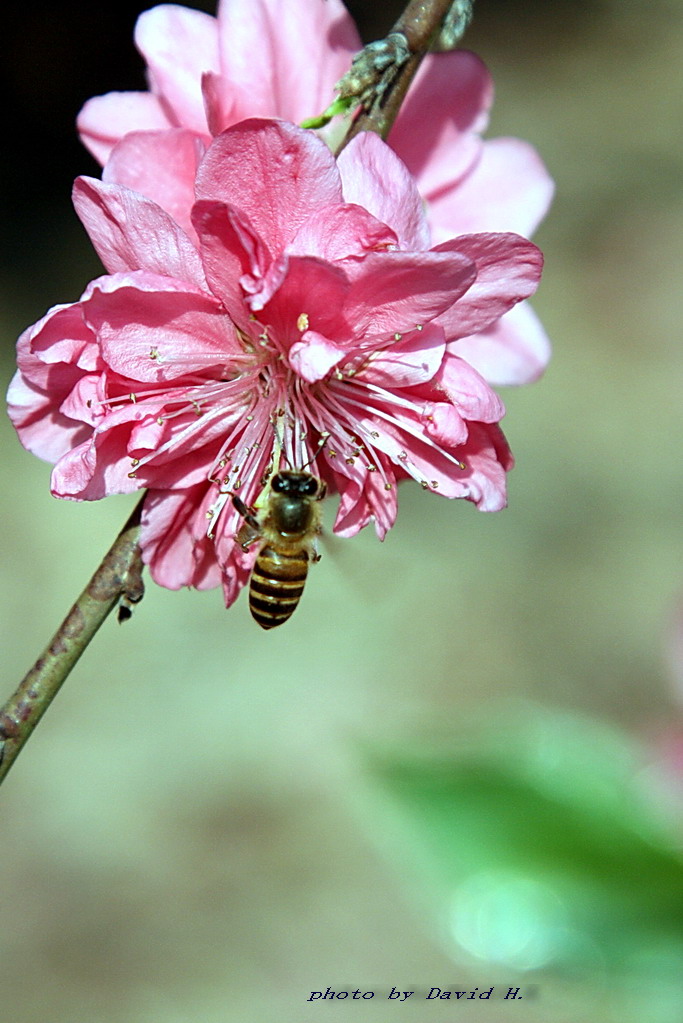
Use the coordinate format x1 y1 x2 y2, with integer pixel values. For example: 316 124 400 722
74 178 206 286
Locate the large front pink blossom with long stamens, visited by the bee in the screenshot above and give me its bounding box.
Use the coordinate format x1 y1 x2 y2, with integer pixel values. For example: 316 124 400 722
8 121 542 604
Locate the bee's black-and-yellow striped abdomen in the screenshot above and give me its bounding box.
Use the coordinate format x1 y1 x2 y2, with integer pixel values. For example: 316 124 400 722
249 545 309 629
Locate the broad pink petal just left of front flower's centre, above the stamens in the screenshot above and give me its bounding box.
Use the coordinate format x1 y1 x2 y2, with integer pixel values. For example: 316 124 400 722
83 271 232 383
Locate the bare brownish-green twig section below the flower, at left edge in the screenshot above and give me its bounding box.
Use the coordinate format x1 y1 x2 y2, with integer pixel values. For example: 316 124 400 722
0 497 144 782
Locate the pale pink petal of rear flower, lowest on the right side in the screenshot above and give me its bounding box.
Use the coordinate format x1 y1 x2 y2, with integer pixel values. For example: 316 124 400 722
452 302 550 386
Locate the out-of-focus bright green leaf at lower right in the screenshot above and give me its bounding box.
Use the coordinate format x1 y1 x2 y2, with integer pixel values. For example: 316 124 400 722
355 706 683 1006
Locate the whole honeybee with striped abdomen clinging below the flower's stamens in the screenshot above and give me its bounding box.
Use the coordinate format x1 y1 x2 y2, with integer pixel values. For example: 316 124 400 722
232 470 326 629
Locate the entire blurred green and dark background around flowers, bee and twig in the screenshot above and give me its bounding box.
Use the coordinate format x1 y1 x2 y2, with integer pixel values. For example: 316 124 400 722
0 0 683 1023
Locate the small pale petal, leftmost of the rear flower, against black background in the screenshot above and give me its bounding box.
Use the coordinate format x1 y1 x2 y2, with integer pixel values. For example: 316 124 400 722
76 92 171 164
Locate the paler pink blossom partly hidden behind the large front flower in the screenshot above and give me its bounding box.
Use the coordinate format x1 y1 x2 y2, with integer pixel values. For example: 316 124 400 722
78 0 552 385
